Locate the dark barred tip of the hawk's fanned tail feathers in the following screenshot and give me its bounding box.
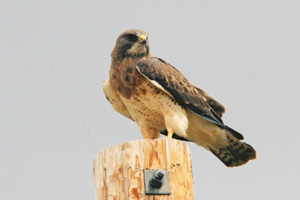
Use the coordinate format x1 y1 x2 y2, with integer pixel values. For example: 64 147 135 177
210 134 256 167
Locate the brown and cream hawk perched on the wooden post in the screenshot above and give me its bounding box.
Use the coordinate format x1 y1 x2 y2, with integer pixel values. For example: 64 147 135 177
103 29 256 167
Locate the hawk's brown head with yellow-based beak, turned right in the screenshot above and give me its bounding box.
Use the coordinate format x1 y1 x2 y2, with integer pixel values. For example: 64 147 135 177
112 29 150 59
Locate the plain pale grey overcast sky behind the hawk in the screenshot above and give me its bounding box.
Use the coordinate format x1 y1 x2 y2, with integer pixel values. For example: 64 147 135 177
0 0 300 200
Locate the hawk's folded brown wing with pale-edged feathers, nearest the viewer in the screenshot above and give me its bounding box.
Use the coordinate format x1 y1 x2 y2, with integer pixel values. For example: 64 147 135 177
136 57 243 139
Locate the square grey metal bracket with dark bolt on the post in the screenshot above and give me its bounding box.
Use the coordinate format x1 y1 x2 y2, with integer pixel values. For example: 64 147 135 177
144 169 171 195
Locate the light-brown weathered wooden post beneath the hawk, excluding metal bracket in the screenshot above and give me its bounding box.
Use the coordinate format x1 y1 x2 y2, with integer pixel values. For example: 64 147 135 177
94 139 194 200
